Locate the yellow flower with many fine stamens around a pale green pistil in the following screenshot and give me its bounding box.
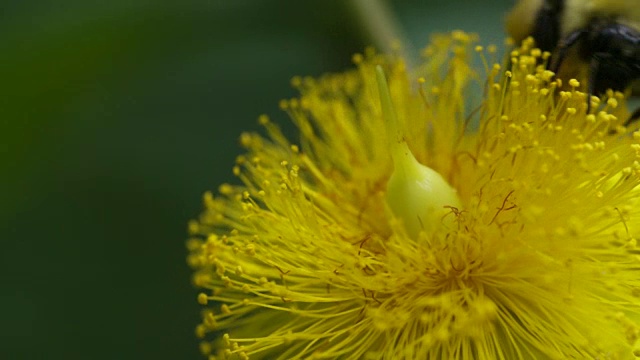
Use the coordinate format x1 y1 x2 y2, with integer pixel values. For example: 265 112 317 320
188 33 640 360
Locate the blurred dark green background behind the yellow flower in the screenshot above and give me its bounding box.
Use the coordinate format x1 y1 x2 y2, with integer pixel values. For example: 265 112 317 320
0 0 511 359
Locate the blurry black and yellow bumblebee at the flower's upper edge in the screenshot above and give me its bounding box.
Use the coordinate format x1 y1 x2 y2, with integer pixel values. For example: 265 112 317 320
506 0 640 123
